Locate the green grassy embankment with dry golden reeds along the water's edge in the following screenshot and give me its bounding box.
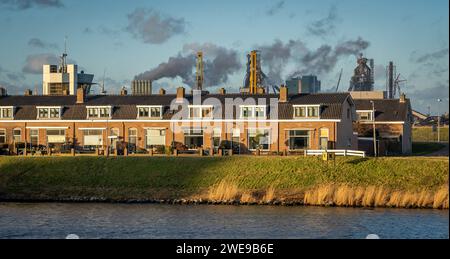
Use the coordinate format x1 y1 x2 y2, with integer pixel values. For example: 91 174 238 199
0 156 448 208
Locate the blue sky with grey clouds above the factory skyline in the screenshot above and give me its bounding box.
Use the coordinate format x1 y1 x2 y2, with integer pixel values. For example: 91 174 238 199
0 0 449 113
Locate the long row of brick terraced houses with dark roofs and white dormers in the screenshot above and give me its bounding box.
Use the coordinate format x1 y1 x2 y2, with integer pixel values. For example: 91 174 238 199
0 87 358 153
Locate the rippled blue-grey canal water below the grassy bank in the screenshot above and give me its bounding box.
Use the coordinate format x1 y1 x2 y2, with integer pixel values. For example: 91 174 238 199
0 203 449 239
